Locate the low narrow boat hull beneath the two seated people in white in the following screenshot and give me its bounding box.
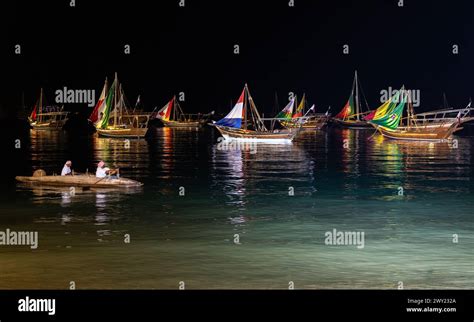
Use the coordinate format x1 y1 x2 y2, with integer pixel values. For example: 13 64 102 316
15 174 143 188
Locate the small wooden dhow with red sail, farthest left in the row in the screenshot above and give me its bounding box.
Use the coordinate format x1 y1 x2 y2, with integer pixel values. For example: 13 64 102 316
28 89 69 130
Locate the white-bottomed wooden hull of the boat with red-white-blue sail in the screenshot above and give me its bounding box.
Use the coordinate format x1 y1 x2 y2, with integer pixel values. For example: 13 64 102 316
214 125 299 143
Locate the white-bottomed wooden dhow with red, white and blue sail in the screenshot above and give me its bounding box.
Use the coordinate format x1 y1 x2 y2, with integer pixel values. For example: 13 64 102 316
209 84 300 143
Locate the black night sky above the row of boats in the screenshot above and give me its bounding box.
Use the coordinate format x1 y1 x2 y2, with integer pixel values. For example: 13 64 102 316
0 0 474 117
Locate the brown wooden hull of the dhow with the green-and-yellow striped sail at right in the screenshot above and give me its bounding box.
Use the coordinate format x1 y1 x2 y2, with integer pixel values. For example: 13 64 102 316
372 122 459 142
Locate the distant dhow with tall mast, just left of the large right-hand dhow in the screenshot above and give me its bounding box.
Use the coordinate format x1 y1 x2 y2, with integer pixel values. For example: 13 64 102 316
331 71 371 129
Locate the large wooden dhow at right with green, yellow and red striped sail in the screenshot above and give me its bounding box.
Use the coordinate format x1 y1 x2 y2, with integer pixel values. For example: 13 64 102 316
366 87 461 142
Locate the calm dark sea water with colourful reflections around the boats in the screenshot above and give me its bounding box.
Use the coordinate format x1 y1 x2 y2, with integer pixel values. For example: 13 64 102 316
0 128 474 289
